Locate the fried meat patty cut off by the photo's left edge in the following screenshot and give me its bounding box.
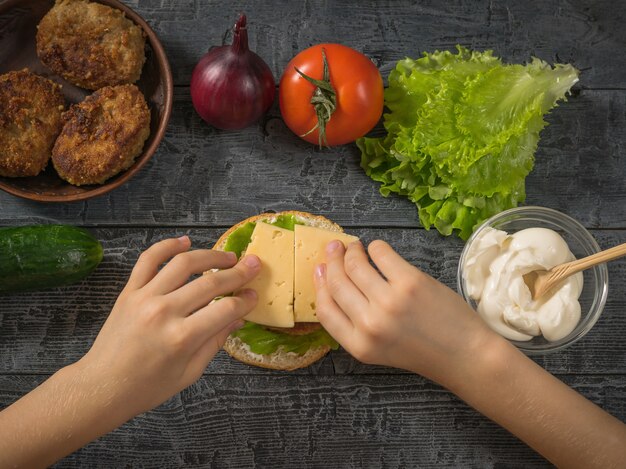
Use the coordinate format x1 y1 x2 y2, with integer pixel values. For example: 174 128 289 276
0 69 65 177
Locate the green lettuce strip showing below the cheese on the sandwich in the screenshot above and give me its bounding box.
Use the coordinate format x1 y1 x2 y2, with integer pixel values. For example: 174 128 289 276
232 321 339 355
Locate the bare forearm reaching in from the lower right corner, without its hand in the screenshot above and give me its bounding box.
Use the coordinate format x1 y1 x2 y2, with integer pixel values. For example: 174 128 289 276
442 340 626 468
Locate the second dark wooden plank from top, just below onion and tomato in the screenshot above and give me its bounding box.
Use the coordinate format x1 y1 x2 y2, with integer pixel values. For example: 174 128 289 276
0 89 626 228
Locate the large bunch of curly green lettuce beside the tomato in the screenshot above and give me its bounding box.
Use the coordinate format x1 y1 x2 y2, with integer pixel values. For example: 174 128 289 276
357 46 578 239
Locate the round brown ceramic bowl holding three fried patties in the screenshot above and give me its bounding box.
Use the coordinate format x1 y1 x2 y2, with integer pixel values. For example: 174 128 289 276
0 0 173 202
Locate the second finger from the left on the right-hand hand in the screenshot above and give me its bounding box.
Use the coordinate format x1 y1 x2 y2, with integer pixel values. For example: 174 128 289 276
326 240 368 317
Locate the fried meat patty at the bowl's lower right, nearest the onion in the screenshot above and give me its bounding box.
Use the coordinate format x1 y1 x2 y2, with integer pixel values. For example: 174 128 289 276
52 85 150 186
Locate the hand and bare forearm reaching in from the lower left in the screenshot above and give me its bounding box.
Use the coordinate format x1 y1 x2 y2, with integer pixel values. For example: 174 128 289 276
0 236 261 467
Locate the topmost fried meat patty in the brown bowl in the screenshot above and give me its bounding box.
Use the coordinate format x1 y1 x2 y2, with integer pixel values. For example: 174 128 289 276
37 0 146 90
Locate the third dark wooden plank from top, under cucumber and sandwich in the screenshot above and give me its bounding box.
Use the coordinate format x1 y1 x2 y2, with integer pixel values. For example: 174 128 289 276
0 225 626 374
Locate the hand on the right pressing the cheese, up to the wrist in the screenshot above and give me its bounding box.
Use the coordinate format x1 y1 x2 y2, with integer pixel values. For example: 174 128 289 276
315 241 499 385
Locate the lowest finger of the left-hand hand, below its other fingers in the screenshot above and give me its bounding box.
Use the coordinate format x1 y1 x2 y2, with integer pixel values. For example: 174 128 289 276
184 290 257 347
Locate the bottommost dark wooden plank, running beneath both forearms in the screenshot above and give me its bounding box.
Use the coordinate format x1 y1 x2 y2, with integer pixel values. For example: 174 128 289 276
0 375 626 468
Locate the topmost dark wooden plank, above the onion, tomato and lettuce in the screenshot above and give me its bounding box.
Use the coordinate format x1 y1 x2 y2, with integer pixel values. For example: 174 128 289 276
119 0 626 88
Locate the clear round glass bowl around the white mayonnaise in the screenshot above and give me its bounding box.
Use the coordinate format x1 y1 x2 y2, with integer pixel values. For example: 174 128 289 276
457 207 609 355
